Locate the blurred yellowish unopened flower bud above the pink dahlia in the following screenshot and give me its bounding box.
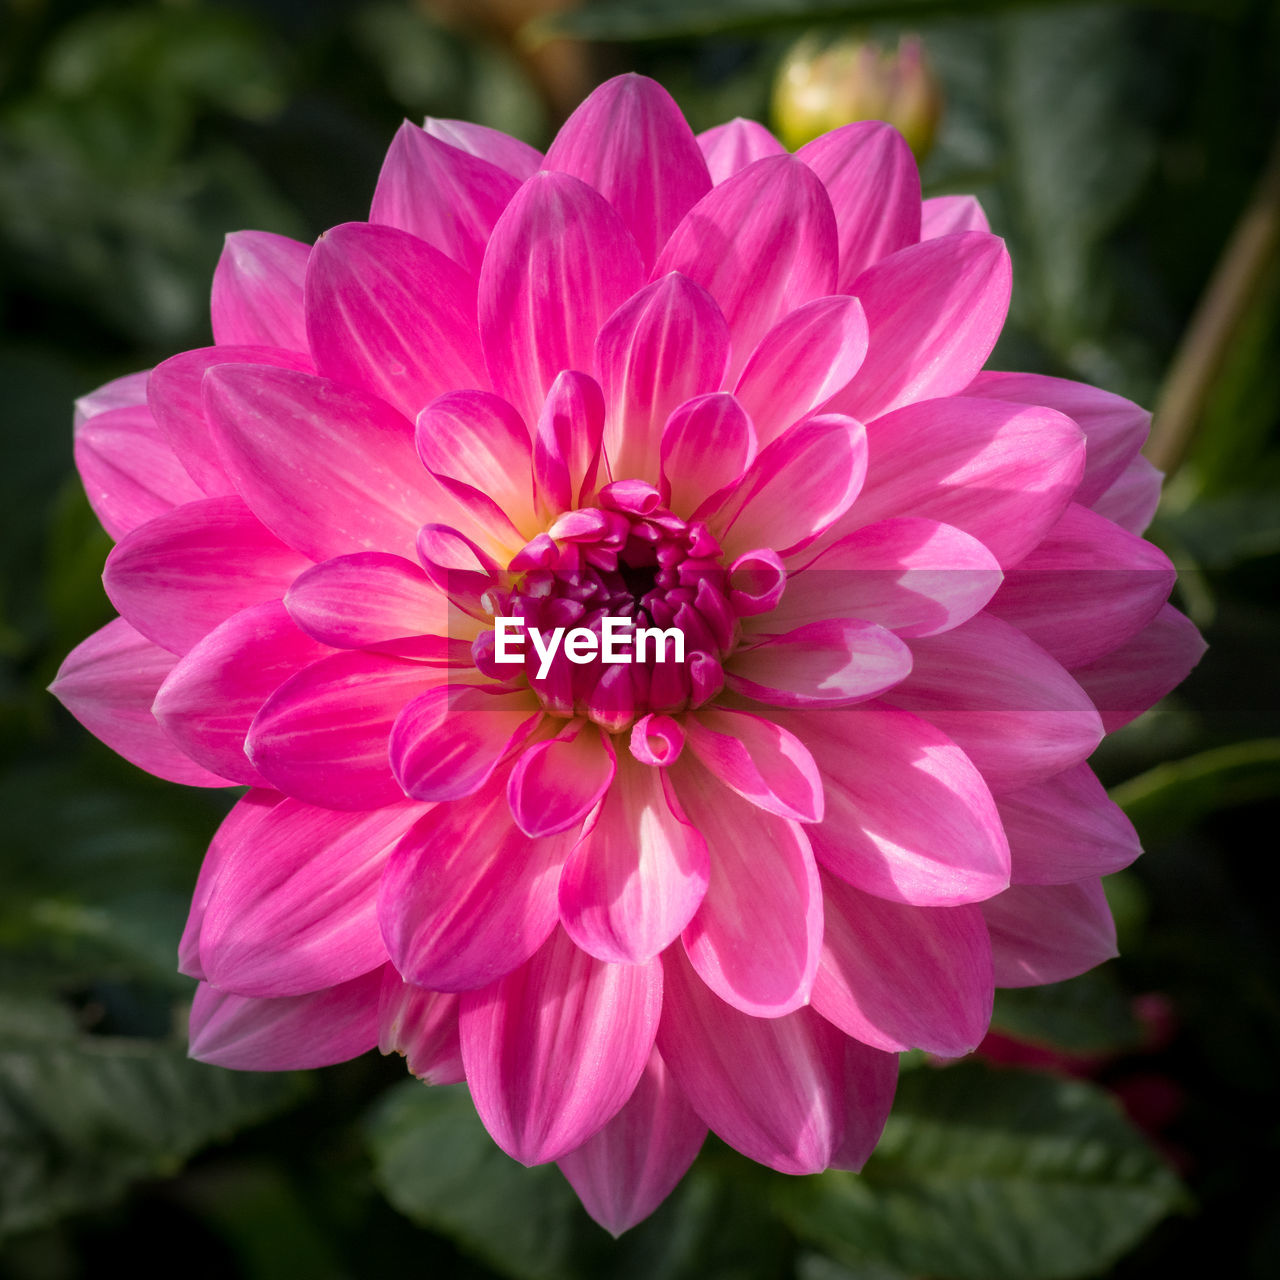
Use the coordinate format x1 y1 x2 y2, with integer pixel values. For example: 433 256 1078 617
773 36 942 160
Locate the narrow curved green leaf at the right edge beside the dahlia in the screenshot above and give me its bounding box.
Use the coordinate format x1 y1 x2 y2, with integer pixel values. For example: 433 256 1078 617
1111 737 1280 844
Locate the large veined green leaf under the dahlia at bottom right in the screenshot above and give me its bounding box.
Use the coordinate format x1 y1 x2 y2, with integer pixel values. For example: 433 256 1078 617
778 1062 1183 1280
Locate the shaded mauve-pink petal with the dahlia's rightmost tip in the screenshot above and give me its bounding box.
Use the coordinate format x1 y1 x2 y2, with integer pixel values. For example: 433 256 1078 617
1071 604 1206 733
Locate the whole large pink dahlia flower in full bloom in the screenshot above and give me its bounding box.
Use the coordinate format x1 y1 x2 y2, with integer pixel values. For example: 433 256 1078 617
54 77 1201 1231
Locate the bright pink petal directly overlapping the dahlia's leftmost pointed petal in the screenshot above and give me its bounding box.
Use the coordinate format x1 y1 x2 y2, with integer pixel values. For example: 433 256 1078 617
152 600 332 783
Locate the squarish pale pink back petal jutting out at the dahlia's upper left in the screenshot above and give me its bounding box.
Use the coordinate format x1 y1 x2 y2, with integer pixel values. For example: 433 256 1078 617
211 232 311 352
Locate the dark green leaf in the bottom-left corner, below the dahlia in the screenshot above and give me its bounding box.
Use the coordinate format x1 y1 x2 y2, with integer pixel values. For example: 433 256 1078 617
0 995 301 1238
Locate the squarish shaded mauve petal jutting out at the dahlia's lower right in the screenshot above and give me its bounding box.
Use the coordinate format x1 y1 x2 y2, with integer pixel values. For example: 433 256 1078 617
982 879 1119 987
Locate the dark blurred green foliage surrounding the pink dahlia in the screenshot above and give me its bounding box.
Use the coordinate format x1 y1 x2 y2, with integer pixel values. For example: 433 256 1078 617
0 0 1280 1280
